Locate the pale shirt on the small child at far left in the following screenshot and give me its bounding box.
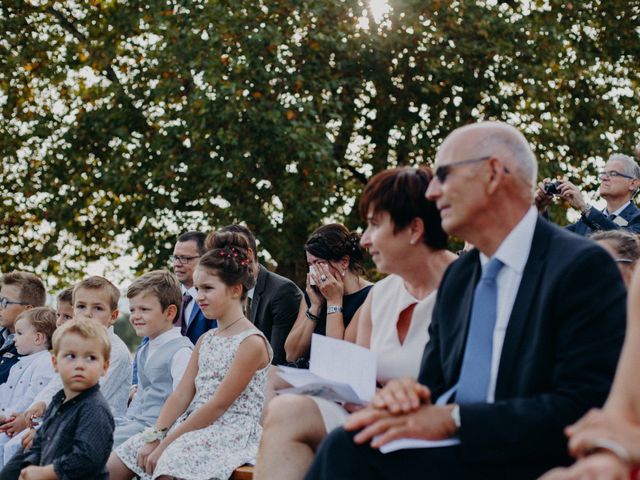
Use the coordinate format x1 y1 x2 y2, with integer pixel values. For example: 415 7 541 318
0 350 56 417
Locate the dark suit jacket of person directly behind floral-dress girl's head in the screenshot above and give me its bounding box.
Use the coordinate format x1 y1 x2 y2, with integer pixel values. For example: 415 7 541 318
250 265 302 365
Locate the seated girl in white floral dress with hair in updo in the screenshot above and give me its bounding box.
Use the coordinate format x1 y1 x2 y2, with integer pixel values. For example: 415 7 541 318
108 232 272 480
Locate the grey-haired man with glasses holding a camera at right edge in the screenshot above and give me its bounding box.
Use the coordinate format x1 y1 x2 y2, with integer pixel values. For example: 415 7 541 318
535 153 640 236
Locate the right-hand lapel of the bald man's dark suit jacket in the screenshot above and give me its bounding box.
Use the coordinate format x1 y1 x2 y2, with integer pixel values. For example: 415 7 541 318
495 219 549 400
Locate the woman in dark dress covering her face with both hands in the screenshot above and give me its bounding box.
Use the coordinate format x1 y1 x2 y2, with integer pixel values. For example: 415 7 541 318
284 223 372 364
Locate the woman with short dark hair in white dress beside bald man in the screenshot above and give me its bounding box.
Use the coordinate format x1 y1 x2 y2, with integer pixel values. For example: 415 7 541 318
254 167 457 480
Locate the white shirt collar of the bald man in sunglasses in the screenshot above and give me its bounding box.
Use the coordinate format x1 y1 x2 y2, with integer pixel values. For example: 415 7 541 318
480 206 538 275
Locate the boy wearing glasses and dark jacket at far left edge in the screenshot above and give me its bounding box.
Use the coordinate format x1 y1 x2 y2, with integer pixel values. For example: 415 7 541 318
0 271 47 385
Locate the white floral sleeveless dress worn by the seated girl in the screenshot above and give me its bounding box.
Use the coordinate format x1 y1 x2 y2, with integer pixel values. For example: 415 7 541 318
115 328 272 480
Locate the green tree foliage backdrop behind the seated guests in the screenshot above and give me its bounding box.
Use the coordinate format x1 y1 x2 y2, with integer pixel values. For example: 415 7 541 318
0 0 640 279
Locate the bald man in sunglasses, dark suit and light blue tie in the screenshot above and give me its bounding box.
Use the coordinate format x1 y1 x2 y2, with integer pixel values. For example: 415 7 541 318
307 122 626 480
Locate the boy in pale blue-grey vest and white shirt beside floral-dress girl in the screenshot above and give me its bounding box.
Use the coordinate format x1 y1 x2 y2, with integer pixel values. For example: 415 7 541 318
113 270 193 447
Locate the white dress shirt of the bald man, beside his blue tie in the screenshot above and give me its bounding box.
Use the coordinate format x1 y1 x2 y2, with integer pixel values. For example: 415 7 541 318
480 207 538 403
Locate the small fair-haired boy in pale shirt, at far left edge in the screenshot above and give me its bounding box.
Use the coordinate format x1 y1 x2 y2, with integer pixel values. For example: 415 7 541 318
0 307 56 468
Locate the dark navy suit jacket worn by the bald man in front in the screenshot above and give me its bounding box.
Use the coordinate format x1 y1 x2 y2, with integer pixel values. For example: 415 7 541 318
419 218 626 478
